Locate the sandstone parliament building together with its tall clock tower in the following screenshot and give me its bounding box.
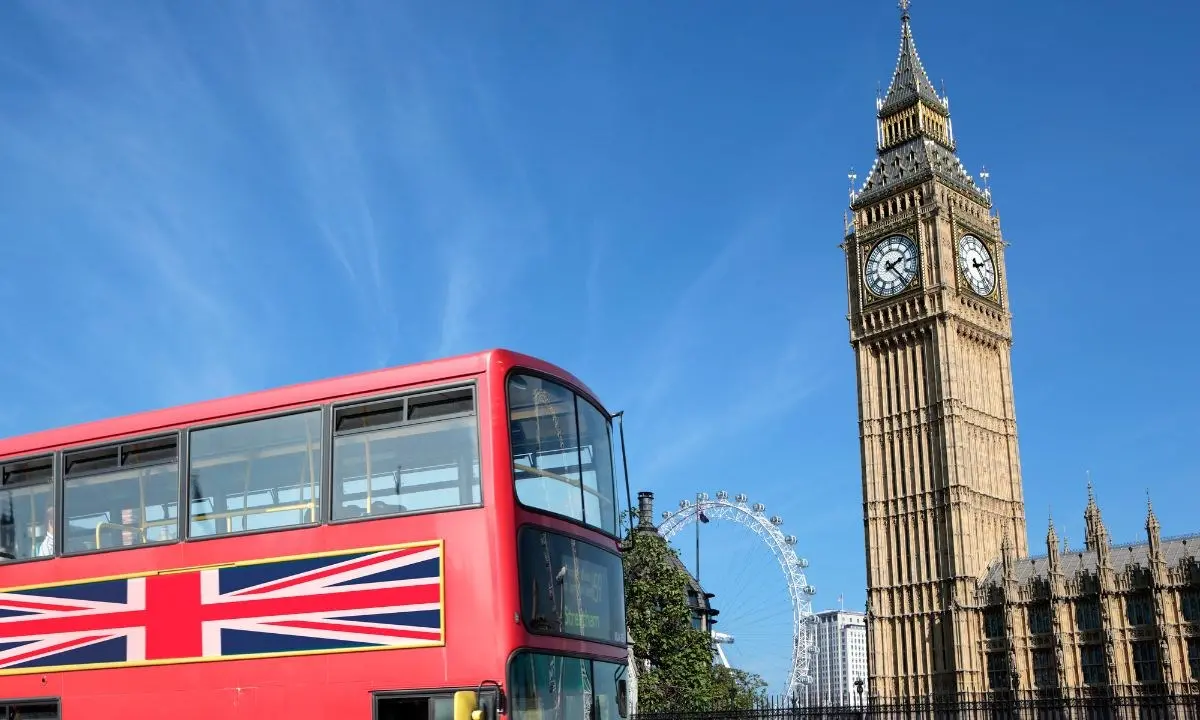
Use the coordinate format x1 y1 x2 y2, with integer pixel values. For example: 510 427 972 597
841 0 1200 702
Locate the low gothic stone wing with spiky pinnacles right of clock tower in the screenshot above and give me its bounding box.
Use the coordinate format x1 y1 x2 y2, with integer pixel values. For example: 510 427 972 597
978 492 1200 695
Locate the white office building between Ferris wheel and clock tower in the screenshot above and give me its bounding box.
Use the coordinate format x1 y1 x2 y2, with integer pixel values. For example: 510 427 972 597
809 610 868 706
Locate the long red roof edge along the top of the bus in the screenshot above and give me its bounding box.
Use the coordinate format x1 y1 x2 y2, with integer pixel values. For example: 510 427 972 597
0 348 607 460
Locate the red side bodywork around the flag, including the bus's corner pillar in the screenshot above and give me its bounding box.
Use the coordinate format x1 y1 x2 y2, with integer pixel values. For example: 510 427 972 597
0 366 535 720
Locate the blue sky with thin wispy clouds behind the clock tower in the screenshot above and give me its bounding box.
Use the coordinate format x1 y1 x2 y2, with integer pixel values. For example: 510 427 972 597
0 0 1200 696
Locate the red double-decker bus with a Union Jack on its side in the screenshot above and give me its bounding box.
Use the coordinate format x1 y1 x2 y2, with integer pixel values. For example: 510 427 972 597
0 350 628 720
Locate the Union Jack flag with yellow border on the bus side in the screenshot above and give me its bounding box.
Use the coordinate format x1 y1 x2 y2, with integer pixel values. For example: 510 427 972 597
0 542 445 673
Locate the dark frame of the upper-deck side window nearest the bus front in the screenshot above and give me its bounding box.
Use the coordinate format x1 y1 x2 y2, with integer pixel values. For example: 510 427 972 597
320 377 487 526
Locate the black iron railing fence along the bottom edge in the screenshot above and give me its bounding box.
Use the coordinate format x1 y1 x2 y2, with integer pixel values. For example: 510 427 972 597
634 691 1200 720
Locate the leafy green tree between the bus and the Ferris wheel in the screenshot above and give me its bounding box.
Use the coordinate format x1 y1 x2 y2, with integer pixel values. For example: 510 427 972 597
624 513 766 713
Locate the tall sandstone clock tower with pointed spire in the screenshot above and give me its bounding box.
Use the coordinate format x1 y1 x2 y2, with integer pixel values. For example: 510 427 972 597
841 0 1027 700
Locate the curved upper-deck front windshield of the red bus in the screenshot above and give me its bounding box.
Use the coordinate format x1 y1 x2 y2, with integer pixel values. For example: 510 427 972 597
508 374 617 535
